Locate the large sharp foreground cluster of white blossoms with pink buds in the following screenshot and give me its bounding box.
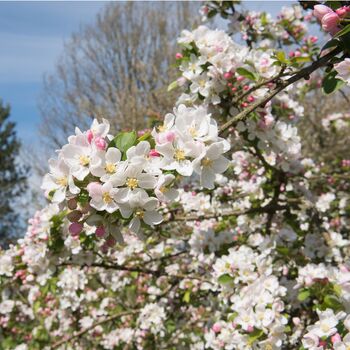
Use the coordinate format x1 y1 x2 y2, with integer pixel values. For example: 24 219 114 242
42 105 230 245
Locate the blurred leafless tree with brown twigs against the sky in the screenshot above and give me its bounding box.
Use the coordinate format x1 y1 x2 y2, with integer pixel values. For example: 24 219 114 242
39 2 199 149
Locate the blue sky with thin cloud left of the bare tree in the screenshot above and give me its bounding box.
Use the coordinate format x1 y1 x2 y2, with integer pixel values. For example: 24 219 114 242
0 2 105 144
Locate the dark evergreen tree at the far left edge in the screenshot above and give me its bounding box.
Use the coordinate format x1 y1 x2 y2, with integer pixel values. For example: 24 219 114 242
0 101 28 244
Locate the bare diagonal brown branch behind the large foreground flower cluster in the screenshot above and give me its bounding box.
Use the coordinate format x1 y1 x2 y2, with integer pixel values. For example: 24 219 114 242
219 47 342 135
